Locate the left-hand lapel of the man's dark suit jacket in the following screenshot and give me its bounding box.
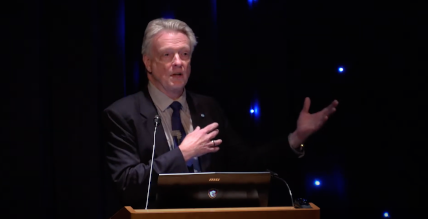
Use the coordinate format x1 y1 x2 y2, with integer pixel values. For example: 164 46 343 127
139 87 169 157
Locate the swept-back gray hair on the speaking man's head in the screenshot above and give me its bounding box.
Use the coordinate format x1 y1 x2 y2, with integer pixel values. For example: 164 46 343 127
141 18 198 55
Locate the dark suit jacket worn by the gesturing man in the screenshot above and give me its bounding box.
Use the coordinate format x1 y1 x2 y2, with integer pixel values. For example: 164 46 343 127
103 89 297 208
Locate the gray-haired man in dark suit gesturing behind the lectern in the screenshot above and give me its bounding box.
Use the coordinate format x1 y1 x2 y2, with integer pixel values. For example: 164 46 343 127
103 19 338 208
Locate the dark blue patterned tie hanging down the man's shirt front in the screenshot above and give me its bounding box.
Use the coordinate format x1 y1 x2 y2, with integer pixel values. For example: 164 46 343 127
171 101 200 172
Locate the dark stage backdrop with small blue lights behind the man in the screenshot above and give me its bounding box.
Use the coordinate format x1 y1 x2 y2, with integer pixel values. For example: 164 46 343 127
5 0 427 218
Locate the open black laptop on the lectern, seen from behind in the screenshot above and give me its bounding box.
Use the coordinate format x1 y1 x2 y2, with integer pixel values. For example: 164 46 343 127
156 172 271 209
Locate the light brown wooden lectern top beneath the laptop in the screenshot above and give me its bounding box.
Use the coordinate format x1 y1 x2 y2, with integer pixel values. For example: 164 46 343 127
111 203 320 219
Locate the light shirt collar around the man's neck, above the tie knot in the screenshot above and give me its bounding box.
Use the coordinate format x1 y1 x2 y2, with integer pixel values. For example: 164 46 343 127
147 82 187 112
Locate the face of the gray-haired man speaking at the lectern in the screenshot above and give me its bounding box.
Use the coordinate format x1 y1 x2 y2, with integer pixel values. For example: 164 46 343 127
143 31 191 98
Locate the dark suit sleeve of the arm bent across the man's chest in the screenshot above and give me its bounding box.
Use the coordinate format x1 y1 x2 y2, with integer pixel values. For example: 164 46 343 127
103 110 188 206
